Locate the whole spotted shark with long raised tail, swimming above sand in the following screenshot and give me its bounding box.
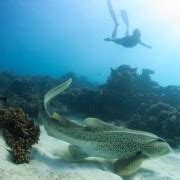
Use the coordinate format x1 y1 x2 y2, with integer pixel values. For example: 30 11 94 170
39 79 171 177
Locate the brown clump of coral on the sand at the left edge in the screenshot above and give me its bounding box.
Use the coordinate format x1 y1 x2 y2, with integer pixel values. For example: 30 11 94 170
0 108 40 164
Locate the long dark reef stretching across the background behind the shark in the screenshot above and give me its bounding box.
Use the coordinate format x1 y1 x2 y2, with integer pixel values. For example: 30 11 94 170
0 65 180 145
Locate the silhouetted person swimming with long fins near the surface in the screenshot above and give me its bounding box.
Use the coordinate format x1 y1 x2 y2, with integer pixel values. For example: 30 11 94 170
104 0 152 49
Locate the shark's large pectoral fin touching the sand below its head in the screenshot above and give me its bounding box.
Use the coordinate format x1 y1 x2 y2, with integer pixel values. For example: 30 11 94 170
114 152 146 177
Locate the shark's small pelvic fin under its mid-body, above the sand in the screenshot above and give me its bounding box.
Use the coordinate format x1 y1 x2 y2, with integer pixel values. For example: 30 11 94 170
68 145 88 160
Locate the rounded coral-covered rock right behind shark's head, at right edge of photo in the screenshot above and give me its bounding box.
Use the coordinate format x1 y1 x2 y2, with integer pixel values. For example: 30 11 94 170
127 102 180 144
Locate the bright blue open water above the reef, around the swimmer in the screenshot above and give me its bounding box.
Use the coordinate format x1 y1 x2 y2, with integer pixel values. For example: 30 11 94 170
0 0 180 85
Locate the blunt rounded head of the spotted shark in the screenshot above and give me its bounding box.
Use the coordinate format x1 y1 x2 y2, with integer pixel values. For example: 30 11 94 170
143 137 171 158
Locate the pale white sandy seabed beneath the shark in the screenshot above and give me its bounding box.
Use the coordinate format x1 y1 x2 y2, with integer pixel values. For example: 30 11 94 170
0 127 180 180
